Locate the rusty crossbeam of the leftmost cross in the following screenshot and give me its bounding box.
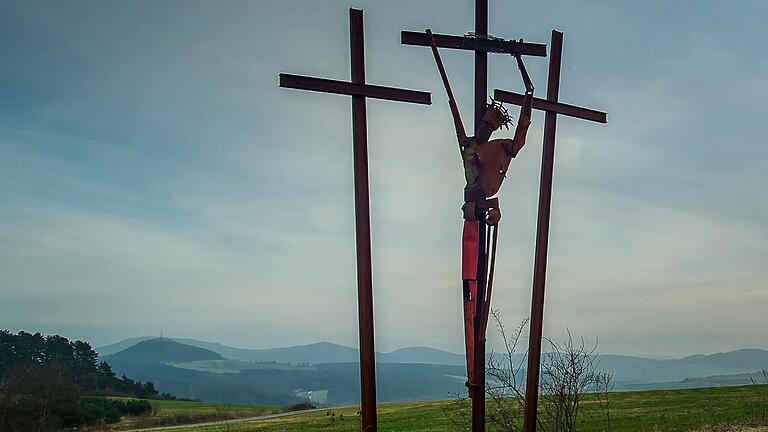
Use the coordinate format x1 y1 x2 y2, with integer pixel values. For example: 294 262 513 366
280 73 432 105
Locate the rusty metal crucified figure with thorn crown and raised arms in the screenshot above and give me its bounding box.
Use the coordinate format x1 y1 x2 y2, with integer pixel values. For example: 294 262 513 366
426 29 534 388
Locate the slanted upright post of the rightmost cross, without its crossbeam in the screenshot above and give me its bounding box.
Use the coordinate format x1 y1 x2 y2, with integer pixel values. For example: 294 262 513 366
523 30 563 432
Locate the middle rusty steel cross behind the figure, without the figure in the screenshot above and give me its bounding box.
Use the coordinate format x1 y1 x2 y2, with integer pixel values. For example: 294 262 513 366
401 0 547 432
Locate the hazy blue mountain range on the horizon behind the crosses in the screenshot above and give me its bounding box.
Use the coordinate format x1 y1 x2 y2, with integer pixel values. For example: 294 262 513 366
97 337 768 405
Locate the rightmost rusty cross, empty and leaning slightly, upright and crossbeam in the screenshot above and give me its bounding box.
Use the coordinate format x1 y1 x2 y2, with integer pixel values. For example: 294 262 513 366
493 30 608 432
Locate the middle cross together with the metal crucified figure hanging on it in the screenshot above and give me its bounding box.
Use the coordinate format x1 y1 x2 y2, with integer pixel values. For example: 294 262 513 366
401 0 547 432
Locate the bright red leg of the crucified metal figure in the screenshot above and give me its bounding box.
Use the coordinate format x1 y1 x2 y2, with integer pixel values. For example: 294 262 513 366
461 220 480 385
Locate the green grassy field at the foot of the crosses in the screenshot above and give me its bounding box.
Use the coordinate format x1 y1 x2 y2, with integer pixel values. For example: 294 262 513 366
141 386 768 432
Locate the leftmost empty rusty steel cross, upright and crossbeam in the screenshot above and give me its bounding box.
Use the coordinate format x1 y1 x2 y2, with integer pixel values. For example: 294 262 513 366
280 9 432 432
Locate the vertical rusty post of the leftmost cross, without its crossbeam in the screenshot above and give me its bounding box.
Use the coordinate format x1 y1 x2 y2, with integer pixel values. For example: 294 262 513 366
349 9 376 432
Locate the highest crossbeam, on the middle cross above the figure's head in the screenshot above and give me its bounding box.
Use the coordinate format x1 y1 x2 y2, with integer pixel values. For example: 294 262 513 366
400 30 547 57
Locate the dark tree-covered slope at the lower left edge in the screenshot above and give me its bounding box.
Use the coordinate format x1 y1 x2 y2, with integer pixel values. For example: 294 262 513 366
0 330 173 432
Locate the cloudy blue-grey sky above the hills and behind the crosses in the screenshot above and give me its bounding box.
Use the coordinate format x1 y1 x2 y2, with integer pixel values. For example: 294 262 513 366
0 0 768 356
